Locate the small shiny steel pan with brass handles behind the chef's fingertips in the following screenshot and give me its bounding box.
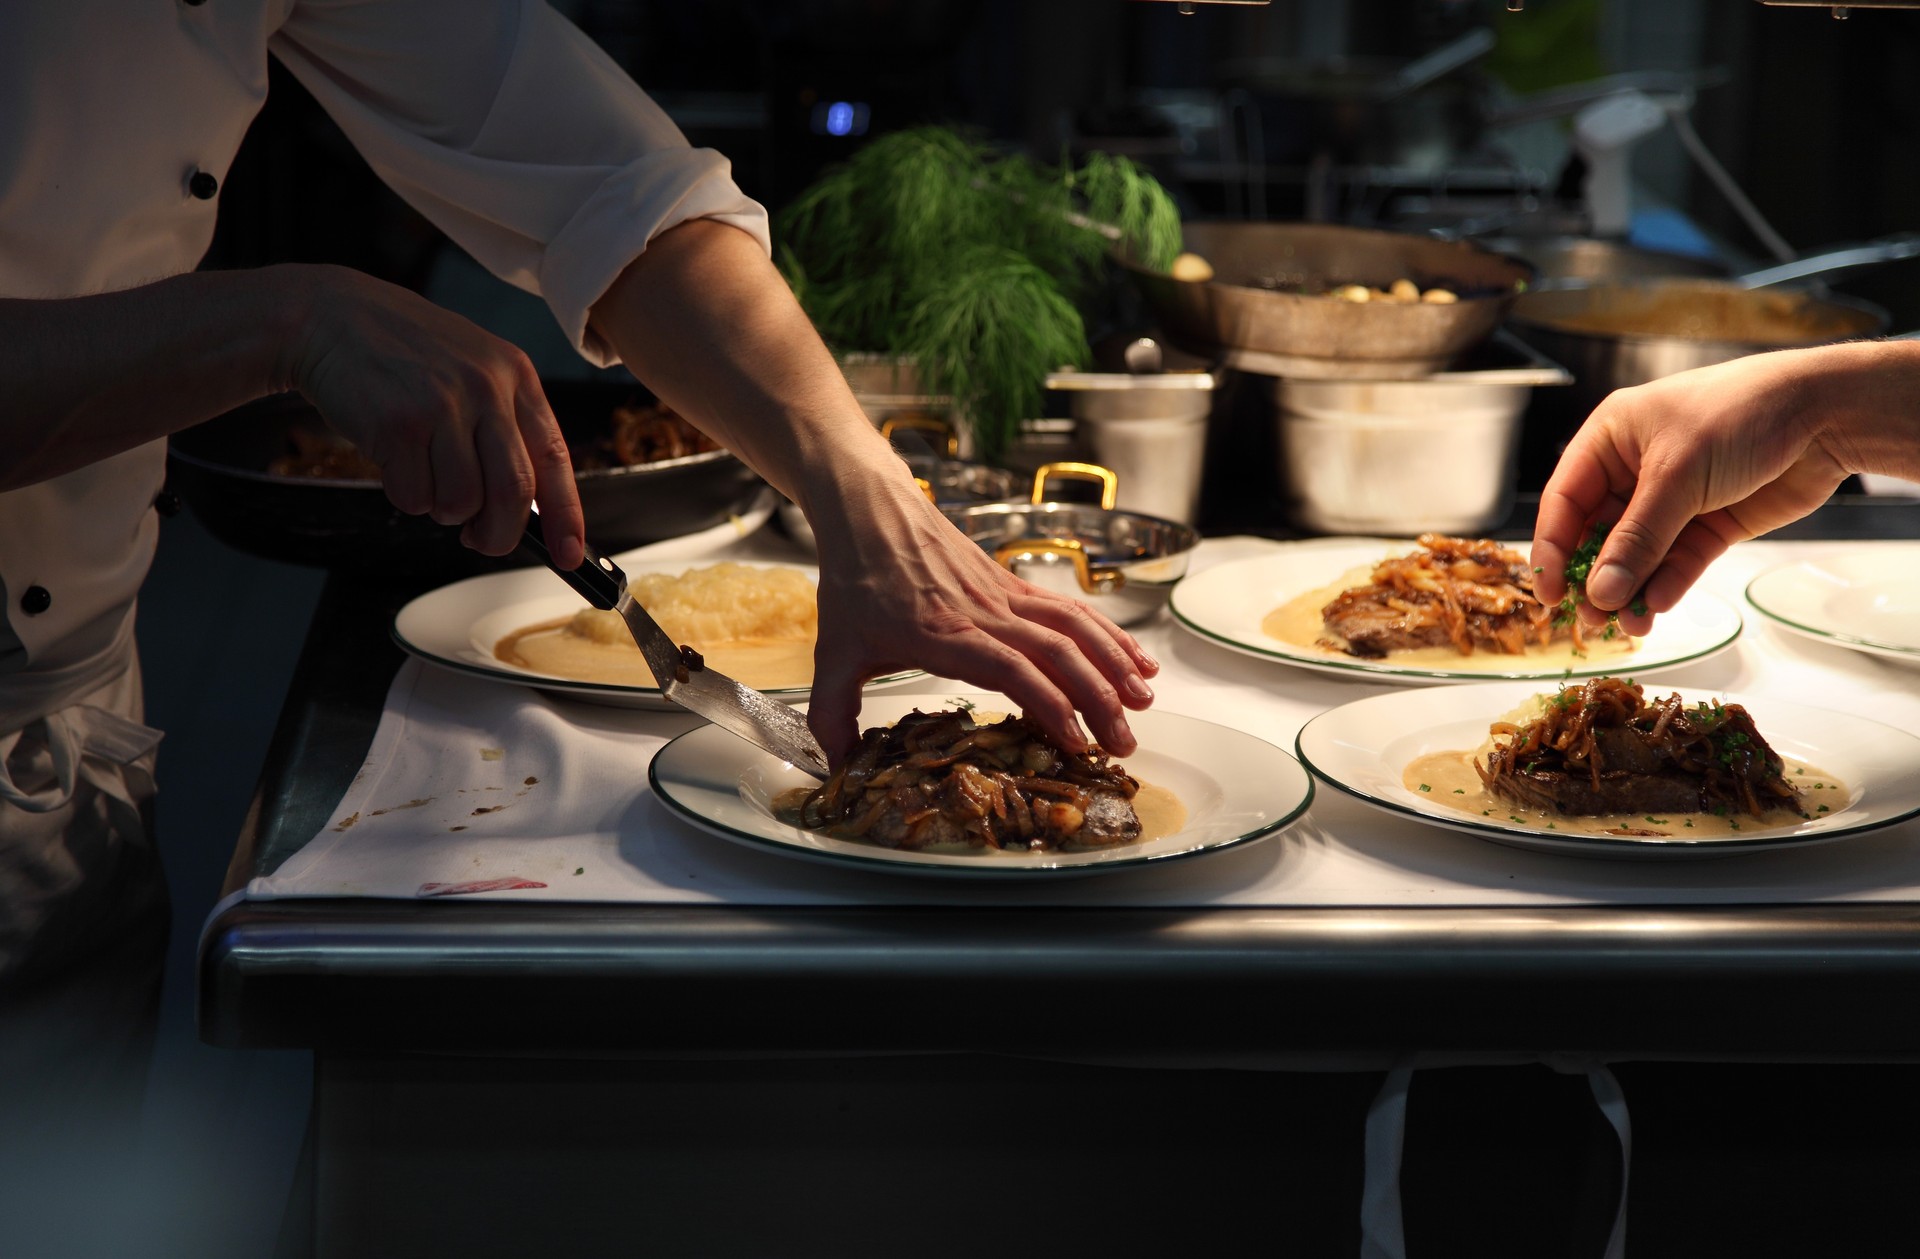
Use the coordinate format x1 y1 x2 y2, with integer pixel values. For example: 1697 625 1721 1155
941 463 1200 626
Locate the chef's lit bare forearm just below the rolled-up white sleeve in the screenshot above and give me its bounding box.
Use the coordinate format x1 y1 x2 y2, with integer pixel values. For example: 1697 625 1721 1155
591 219 900 516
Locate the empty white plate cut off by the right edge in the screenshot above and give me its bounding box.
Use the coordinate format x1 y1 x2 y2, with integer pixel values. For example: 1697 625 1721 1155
1747 545 1920 660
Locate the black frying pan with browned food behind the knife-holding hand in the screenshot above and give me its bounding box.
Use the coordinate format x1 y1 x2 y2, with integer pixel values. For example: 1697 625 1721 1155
167 382 764 578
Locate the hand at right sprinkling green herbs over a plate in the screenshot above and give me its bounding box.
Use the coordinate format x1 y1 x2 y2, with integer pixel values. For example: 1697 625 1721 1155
1532 345 1864 635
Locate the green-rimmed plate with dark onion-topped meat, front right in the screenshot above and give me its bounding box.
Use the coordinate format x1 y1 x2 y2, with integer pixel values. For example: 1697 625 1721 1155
1296 677 1920 858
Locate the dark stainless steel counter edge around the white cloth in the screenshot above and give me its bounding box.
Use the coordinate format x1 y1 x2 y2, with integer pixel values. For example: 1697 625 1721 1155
200 501 1920 1067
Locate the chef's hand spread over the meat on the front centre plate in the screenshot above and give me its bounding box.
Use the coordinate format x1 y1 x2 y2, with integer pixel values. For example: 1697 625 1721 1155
808 460 1160 764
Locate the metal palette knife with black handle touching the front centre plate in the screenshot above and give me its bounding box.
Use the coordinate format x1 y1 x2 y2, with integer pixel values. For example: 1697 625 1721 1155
522 509 828 779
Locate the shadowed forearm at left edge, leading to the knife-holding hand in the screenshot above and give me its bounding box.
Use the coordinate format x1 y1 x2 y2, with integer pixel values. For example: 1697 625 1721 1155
0 267 301 489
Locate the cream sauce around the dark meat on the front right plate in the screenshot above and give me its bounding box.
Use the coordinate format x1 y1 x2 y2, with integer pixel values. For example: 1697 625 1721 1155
1400 743 1849 841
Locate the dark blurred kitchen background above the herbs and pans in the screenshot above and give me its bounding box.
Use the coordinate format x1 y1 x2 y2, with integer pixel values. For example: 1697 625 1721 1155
207 0 1920 343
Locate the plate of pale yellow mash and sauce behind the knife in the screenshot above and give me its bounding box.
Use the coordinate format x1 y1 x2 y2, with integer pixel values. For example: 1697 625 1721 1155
394 557 922 710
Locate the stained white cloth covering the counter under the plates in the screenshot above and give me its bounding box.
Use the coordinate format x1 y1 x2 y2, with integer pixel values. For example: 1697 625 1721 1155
246 539 1920 906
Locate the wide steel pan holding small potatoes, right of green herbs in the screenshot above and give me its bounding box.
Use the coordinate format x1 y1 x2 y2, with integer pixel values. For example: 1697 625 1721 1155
1121 223 1532 380
